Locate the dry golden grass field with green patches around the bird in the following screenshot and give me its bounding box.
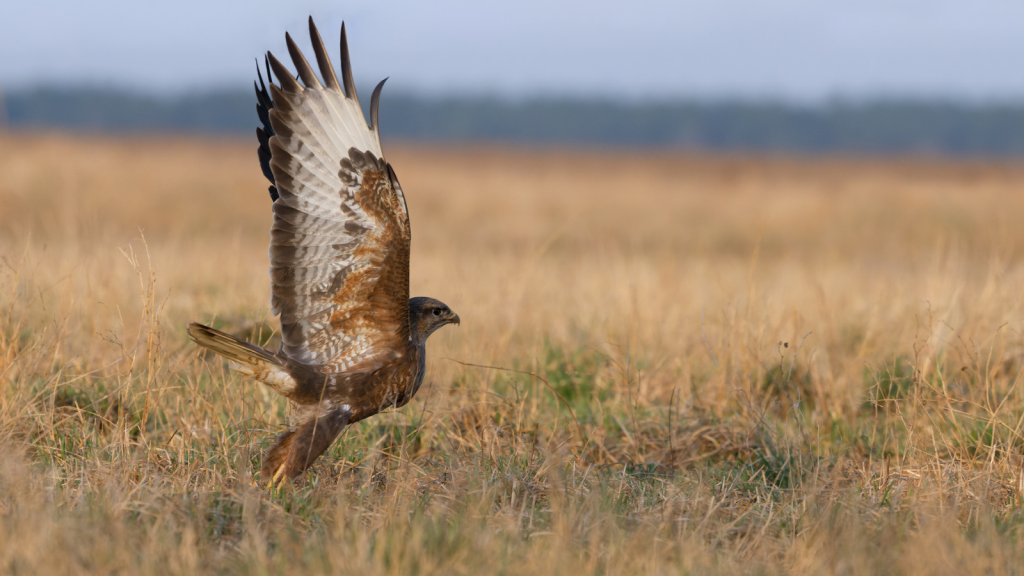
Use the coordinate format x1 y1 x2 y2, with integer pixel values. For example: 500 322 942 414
0 133 1024 575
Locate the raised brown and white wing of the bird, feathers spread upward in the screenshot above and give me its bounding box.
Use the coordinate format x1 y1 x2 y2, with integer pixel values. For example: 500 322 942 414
257 18 411 372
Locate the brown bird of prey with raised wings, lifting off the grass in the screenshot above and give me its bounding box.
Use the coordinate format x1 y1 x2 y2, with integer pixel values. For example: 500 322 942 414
188 17 460 485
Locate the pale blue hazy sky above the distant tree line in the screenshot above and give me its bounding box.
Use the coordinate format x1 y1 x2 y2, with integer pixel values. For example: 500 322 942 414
0 0 1024 100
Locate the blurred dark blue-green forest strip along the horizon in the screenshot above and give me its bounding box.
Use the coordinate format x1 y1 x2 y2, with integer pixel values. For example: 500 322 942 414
5 86 1024 152
